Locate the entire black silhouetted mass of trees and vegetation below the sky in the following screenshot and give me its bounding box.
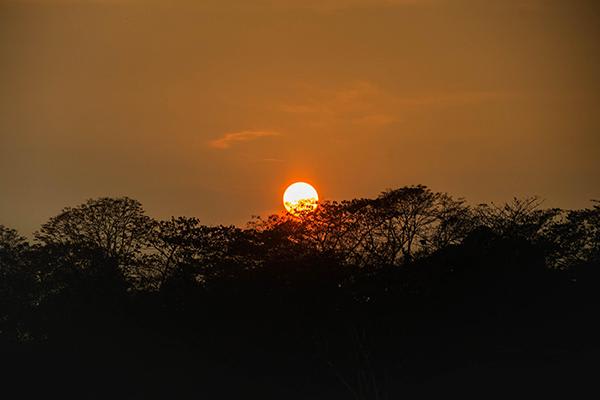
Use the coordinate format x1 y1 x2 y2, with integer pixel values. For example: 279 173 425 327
0 186 600 399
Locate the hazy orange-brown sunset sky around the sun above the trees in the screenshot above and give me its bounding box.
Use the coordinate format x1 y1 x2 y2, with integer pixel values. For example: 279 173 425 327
0 0 600 234
